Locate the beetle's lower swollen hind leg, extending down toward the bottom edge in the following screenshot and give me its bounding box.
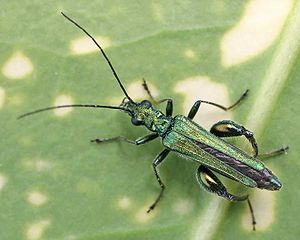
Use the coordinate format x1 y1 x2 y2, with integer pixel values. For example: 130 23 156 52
196 165 256 230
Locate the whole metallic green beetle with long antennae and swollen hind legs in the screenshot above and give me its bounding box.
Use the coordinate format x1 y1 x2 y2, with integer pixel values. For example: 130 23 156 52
19 13 287 229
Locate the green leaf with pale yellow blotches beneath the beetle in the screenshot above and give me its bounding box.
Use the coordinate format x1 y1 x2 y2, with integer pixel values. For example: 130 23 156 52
0 0 300 240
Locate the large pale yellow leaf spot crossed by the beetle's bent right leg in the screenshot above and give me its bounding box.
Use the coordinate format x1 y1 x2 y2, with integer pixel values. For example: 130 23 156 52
175 76 231 129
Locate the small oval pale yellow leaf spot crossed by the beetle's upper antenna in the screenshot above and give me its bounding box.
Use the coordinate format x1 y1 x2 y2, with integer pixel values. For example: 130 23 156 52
70 36 111 55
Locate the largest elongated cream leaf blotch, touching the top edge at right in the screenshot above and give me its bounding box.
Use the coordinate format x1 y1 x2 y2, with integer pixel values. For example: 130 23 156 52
221 0 293 67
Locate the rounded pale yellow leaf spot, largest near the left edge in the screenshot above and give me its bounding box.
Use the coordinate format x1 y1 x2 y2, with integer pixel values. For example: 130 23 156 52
2 52 33 79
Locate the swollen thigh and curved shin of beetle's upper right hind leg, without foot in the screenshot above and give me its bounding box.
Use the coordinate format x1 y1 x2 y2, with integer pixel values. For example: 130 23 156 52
210 120 258 157
